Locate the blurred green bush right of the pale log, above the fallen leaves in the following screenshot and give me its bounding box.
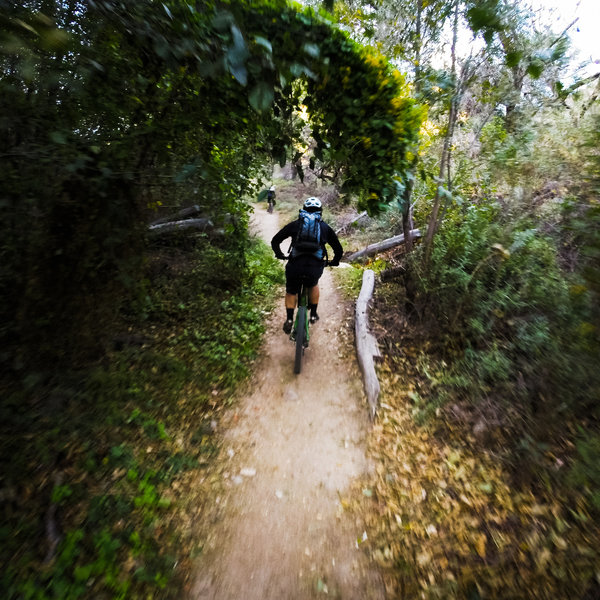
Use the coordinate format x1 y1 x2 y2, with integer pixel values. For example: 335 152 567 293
414 202 599 426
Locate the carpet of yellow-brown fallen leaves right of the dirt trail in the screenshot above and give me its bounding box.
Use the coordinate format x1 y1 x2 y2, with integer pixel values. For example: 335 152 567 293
360 360 600 600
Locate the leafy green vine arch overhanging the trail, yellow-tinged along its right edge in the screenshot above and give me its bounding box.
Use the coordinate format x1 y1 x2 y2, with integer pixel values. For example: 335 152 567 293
223 3 423 212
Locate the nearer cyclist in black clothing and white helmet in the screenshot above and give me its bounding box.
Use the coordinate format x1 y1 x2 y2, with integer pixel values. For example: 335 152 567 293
271 196 343 333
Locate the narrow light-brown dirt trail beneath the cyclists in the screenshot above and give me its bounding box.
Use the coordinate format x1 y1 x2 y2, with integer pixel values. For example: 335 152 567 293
191 208 384 600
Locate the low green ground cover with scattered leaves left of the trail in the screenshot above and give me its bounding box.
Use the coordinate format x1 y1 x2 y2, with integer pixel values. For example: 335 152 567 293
0 238 283 599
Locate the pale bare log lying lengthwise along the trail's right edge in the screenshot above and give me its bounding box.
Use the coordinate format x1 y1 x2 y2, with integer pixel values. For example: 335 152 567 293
354 269 381 419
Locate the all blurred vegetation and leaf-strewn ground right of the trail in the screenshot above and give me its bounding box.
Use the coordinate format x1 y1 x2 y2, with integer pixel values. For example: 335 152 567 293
324 0 600 599
